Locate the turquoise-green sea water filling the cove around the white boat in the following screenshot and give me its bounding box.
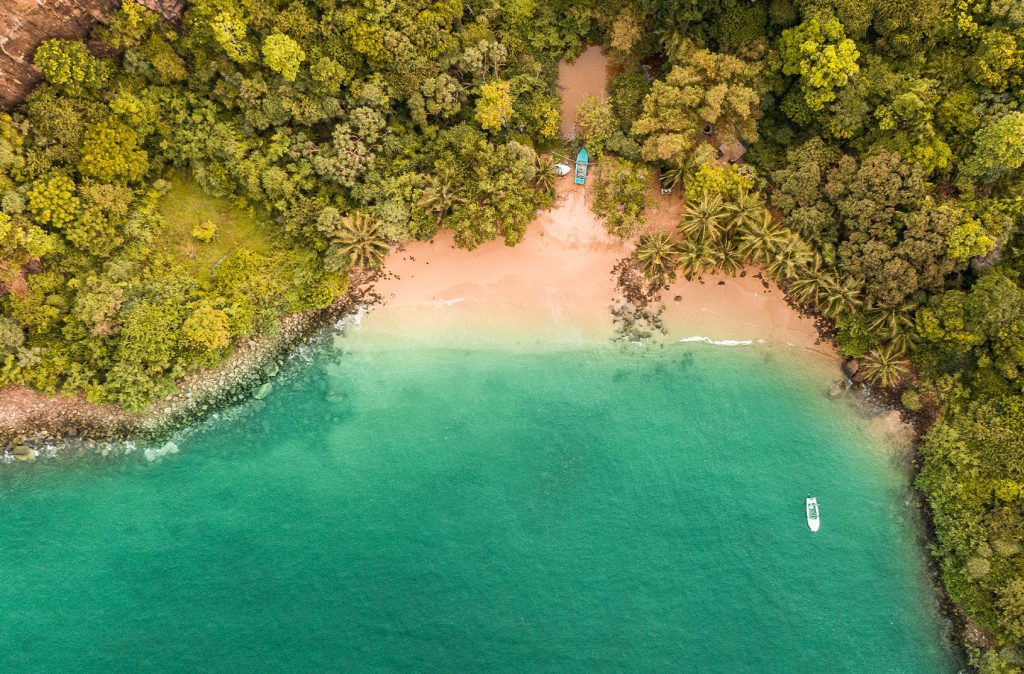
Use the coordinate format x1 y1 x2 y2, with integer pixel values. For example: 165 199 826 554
0 341 955 672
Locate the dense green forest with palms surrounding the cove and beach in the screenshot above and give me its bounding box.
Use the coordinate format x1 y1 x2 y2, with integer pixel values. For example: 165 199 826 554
0 0 1024 672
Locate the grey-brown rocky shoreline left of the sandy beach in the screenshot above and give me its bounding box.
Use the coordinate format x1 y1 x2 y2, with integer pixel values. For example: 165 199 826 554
0 276 380 463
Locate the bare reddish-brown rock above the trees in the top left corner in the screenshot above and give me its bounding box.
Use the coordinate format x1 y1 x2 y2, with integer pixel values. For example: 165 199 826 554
0 0 184 109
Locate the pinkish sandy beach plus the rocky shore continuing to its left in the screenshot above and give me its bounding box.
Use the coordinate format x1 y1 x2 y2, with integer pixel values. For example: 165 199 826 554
0 179 841 450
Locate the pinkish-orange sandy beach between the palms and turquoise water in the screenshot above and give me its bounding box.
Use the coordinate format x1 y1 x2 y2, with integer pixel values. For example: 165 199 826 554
366 177 835 357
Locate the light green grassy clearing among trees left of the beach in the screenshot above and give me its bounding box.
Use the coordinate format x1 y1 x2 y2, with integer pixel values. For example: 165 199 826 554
158 171 273 278
